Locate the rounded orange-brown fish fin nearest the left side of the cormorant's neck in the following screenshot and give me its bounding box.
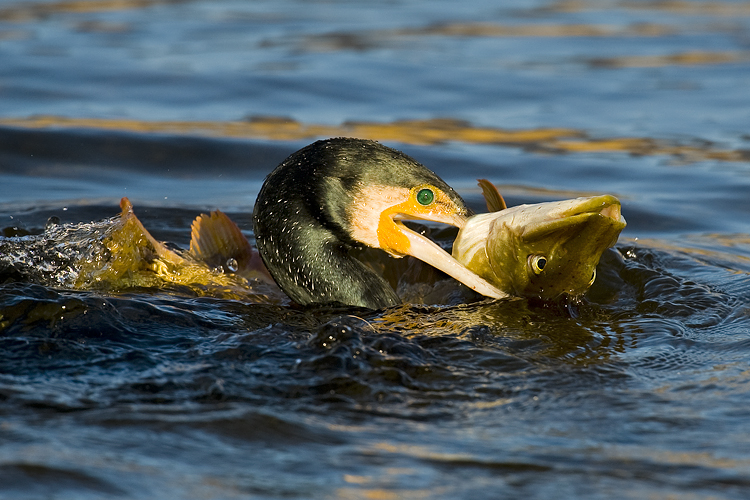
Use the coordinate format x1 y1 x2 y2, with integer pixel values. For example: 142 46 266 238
190 210 252 263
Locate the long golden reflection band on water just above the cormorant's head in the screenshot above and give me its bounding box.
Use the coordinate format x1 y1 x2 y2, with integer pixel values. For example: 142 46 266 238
0 116 750 162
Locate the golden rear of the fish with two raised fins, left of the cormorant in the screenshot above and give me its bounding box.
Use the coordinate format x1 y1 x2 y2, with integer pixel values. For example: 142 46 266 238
75 198 280 302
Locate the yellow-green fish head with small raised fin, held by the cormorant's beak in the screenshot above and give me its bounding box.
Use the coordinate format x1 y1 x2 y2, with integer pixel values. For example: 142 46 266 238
452 179 627 300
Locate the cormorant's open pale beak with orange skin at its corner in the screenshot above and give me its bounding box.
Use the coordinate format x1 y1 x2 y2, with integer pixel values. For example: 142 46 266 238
378 207 509 299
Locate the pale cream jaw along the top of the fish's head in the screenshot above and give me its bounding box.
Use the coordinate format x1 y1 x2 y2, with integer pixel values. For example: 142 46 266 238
513 194 627 241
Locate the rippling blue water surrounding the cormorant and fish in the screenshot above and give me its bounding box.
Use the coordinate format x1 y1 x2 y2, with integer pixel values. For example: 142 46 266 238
0 0 750 499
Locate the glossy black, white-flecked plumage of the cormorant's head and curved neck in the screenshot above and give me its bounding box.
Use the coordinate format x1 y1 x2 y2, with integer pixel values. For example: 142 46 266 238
253 138 469 309
